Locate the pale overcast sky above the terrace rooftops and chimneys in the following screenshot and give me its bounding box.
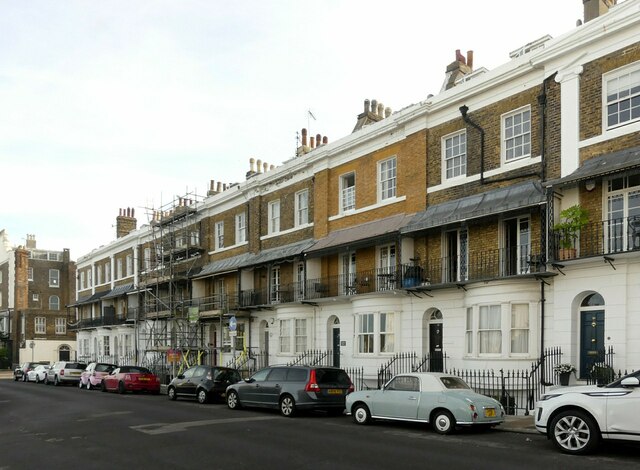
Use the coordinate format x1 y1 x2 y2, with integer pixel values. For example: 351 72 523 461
0 0 582 259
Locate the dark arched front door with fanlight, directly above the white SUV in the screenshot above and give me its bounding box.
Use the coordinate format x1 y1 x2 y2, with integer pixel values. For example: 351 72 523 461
580 293 605 379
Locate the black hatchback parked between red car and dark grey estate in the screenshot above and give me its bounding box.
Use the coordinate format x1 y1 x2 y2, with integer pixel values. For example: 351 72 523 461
167 365 242 403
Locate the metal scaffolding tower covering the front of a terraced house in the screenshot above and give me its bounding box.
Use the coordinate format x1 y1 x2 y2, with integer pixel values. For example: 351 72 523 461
137 193 210 380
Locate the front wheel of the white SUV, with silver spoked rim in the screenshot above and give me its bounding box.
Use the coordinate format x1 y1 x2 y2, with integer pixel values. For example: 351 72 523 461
551 410 600 455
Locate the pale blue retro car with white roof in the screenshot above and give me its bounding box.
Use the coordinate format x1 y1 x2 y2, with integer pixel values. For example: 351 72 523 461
346 372 505 434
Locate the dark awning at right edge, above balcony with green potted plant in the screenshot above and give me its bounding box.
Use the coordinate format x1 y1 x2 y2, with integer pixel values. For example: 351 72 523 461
545 147 640 187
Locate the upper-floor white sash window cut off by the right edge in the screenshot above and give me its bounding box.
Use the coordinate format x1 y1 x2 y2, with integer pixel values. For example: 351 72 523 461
602 61 640 130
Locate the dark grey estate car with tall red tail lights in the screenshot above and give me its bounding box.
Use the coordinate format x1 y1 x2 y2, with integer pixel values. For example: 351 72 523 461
227 366 353 416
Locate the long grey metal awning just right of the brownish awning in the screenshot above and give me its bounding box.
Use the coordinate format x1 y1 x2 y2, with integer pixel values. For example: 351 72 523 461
401 181 546 234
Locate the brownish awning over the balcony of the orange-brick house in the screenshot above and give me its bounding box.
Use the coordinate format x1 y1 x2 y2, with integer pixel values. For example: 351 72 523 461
306 214 413 256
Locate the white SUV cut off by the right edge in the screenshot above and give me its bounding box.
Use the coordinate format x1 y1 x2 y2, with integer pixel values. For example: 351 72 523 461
535 370 640 454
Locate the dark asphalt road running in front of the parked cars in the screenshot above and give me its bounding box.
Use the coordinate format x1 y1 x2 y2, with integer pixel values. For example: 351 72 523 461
0 380 640 470
